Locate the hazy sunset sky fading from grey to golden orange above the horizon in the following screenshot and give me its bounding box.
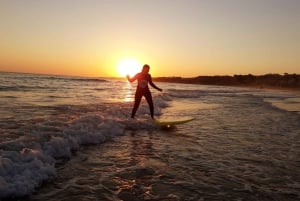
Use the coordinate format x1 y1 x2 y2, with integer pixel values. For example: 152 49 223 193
0 0 300 77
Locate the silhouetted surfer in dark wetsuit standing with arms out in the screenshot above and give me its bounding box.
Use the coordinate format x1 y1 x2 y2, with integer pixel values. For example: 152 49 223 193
127 64 162 119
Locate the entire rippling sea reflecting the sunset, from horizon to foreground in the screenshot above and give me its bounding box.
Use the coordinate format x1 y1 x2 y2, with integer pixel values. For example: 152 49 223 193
0 73 300 201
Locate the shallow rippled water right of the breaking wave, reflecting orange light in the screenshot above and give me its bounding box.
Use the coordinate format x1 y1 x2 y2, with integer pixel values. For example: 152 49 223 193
33 90 300 200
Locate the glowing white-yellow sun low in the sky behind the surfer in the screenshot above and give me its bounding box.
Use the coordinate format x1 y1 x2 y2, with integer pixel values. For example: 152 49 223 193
117 58 141 77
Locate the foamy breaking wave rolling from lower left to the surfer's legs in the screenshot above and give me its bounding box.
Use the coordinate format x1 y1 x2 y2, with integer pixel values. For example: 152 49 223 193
0 95 168 198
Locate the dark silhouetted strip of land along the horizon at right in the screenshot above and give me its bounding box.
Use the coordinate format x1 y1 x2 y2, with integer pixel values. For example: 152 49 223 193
153 73 300 90
